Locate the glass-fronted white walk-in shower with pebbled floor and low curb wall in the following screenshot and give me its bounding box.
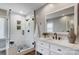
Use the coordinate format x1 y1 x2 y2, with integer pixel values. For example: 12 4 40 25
8 11 34 55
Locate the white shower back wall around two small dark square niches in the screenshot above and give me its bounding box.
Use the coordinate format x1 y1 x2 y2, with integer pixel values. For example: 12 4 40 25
10 13 25 46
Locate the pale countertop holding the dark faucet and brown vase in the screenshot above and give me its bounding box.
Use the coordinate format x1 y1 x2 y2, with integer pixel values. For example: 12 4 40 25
39 38 79 50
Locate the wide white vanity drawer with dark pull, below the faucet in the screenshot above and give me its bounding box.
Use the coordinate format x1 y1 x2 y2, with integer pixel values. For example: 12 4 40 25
50 45 74 55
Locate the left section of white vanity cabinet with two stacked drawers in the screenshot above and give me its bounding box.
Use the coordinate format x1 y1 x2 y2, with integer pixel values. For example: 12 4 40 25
36 40 49 55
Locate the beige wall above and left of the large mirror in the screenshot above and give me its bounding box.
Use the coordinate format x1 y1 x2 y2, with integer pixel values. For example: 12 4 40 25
36 3 74 36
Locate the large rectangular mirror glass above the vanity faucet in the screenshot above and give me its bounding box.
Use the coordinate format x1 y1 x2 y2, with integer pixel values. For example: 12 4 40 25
46 7 74 32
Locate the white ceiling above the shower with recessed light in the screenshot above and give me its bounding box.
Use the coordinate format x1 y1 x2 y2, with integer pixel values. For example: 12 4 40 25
0 3 45 15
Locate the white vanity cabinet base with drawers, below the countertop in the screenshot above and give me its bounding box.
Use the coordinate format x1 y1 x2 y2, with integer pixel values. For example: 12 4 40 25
36 40 79 55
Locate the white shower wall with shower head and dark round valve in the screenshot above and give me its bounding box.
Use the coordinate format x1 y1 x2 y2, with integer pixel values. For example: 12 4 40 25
25 12 34 48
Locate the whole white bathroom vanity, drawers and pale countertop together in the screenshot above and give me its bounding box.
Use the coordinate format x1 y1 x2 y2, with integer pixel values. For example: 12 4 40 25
36 38 79 55
